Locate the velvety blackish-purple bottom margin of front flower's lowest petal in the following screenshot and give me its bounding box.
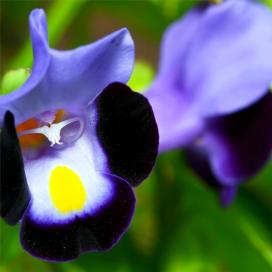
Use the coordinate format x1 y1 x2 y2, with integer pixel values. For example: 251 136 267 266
21 175 135 261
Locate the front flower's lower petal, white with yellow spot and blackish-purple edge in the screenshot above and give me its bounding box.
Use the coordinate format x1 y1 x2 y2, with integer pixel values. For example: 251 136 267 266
21 133 135 261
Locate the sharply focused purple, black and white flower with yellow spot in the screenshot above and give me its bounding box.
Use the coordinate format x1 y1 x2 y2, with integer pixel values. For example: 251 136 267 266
0 9 158 261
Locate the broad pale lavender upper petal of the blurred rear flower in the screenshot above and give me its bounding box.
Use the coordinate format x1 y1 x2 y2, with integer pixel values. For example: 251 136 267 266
150 0 272 116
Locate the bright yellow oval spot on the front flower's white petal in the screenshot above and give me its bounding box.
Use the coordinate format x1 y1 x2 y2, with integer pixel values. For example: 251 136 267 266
49 166 87 214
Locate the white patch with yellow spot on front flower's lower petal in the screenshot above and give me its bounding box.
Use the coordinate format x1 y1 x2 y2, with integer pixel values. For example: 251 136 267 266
25 133 112 223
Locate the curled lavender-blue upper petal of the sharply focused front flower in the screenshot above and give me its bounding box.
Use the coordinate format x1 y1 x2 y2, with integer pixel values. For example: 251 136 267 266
0 10 134 124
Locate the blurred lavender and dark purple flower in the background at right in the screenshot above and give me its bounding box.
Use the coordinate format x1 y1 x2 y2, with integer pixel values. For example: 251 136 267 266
145 0 272 205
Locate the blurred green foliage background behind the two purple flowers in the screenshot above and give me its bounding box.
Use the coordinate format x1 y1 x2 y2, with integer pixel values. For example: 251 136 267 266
0 0 272 272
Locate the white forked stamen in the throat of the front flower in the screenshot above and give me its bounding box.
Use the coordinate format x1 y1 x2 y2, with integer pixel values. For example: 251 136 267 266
19 117 84 147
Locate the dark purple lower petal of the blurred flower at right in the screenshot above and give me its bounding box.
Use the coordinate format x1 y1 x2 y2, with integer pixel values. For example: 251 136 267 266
204 93 272 185
